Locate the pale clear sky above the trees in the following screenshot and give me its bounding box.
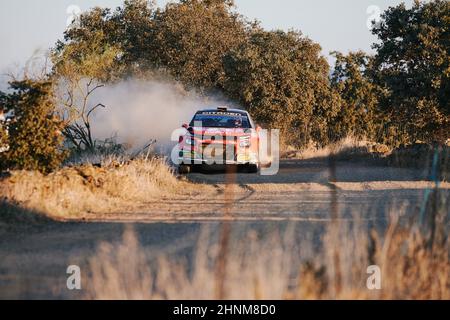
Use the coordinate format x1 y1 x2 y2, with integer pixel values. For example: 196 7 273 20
0 0 413 90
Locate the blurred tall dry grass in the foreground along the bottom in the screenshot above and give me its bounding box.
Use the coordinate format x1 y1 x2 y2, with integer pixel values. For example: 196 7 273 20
86 189 450 299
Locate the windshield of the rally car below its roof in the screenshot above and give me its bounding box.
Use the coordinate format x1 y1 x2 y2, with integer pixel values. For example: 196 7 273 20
190 112 250 129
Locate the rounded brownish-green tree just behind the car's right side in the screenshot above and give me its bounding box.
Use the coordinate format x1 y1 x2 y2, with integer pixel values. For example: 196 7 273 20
224 28 339 146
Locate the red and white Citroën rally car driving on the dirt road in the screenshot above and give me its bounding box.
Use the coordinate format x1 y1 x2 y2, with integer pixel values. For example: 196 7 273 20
178 107 260 173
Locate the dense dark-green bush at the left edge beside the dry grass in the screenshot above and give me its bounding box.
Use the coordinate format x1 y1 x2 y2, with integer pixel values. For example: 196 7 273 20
0 79 65 172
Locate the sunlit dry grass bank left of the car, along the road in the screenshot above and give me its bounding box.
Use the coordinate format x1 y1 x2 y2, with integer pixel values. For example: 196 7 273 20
0 159 207 218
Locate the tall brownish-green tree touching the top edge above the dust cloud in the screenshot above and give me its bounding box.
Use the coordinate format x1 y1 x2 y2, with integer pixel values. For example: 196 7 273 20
150 0 246 89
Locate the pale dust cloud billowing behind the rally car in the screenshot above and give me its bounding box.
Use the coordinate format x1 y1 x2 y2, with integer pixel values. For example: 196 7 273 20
91 80 227 153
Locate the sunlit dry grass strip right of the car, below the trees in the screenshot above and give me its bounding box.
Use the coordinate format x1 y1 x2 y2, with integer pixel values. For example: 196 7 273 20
282 137 392 159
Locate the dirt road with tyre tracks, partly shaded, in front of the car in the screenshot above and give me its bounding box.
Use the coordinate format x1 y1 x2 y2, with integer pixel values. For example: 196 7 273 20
0 160 450 299
